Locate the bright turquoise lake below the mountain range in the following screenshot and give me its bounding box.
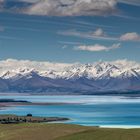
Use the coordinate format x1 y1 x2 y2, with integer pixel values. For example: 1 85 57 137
0 95 140 127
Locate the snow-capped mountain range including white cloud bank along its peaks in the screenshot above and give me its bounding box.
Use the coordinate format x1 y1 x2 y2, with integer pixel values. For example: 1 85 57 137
0 59 140 93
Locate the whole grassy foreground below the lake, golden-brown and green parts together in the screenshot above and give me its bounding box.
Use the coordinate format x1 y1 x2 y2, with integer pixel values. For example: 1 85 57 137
0 124 140 140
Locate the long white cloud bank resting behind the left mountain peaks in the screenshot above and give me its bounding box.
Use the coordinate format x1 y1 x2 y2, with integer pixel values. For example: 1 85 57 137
0 59 72 73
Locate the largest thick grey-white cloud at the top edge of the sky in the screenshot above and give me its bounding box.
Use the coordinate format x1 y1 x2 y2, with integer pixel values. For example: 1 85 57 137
24 0 117 16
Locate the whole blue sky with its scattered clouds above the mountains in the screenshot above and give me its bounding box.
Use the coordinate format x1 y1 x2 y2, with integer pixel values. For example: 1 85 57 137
0 0 140 63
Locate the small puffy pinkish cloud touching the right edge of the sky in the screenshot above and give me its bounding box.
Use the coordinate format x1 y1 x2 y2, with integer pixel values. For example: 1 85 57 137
120 32 140 41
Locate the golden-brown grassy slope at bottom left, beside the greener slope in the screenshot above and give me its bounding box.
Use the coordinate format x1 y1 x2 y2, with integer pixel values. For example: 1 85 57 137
0 123 87 140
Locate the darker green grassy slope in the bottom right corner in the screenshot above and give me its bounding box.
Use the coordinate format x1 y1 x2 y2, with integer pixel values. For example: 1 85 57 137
56 129 140 140
